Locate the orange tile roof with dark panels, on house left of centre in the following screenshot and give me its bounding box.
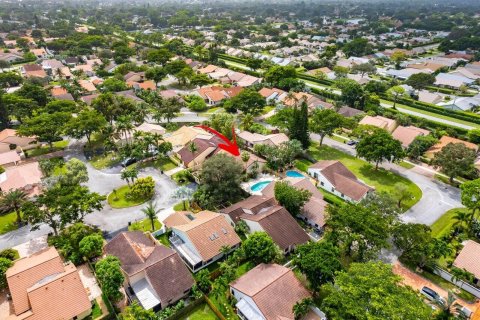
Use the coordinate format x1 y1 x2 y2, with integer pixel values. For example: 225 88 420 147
172 211 241 261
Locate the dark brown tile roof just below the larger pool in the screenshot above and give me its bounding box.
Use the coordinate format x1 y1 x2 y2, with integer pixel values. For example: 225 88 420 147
240 205 310 250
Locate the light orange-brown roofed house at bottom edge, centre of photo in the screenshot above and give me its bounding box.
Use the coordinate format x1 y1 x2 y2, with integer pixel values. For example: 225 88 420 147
230 263 310 320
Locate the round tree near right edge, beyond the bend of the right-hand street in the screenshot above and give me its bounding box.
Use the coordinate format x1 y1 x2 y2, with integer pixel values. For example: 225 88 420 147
432 143 475 183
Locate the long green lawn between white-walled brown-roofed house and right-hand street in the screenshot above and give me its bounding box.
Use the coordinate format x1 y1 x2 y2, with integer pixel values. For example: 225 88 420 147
308 143 422 211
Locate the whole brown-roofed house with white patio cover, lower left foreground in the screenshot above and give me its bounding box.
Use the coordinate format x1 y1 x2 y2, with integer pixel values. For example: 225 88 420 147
104 231 194 311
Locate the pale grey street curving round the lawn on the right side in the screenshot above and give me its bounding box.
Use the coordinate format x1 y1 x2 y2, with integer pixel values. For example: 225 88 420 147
311 134 463 226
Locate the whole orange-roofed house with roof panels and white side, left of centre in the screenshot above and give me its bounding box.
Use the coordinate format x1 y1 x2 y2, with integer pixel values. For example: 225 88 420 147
169 211 241 272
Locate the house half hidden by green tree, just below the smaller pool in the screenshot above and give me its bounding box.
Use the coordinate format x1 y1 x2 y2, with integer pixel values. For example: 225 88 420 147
262 177 328 231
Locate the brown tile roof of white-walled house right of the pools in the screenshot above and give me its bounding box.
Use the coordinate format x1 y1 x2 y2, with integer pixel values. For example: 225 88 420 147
309 160 371 201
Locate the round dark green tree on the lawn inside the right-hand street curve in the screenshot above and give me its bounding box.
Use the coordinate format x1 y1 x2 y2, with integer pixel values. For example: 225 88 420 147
357 129 405 170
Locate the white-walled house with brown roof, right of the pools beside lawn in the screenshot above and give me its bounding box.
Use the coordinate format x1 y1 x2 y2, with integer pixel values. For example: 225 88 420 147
308 160 373 202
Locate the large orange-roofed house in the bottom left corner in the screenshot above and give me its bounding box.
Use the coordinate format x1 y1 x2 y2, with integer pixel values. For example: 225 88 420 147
6 247 92 320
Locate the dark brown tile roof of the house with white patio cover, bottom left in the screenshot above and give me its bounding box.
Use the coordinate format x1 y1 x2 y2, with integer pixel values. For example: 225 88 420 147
105 231 194 306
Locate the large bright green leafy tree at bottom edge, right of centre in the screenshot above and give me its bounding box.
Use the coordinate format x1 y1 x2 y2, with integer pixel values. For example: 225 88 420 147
321 262 433 320
